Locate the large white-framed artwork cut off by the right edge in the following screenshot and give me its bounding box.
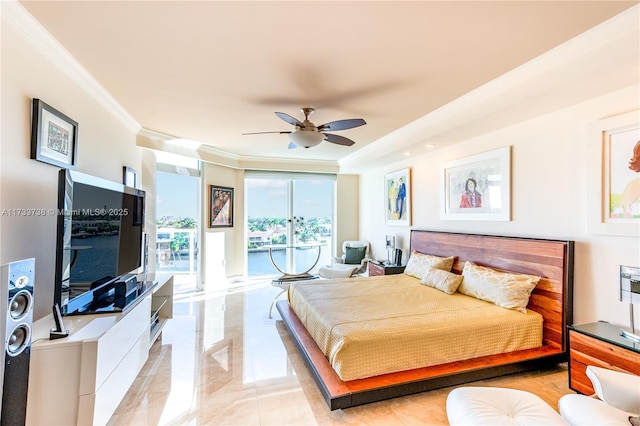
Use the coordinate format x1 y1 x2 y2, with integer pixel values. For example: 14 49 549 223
587 111 640 237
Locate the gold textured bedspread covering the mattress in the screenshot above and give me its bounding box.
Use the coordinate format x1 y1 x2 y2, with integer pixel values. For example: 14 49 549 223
289 274 542 381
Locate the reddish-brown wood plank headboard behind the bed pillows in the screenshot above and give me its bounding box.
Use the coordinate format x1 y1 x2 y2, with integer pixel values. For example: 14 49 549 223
411 230 574 351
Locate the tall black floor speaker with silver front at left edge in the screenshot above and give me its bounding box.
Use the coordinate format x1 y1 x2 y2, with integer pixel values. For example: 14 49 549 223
0 259 35 426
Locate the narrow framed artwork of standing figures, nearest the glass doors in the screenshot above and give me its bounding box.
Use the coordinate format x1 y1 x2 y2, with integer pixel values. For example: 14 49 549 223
384 169 411 226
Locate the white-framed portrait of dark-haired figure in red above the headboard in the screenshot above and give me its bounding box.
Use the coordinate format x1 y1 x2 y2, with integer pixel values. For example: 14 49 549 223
440 146 511 221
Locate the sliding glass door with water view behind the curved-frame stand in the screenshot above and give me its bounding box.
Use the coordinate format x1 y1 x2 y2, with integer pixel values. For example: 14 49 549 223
245 172 335 277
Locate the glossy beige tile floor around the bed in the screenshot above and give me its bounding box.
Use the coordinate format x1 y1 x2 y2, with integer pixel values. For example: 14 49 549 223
109 283 572 425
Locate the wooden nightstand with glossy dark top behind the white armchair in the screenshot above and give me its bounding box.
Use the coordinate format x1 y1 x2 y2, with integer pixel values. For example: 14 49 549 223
567 321 640 395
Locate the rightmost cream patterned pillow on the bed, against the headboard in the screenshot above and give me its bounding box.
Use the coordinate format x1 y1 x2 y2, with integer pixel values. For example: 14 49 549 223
458 262 540 313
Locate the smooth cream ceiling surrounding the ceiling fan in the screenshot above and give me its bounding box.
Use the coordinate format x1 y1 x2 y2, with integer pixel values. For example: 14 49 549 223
21 1 638 171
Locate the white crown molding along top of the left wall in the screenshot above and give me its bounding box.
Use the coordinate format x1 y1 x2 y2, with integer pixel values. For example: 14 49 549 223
0 0 141 133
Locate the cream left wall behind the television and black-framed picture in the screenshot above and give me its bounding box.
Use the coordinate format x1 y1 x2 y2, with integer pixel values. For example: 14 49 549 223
0 3 141 319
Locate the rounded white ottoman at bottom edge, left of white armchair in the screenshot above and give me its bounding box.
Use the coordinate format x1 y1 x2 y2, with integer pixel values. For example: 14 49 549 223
447 387 569 426
